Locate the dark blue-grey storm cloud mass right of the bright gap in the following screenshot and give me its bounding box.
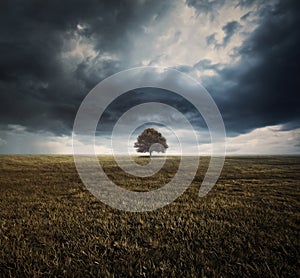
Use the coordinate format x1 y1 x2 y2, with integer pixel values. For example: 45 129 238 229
200 0 300 134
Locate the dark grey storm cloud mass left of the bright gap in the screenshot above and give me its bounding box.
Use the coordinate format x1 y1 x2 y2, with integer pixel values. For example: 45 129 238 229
0 0 171 134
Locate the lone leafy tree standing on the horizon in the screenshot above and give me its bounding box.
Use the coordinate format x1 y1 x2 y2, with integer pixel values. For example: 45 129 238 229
134 128 169 157
